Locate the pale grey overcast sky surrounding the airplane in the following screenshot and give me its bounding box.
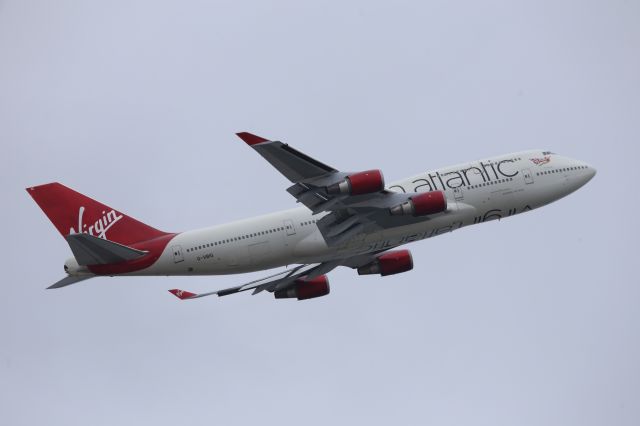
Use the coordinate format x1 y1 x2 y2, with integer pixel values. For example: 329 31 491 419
0 0 640 426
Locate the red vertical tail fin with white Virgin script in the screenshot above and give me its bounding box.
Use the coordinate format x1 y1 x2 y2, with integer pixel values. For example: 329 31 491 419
27 182 166 245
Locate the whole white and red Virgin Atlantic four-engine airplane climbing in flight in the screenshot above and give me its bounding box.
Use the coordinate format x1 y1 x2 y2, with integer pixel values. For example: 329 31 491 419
27 132 596 300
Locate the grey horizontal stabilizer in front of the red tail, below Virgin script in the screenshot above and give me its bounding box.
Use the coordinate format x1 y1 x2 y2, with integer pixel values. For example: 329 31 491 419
65 234 147 266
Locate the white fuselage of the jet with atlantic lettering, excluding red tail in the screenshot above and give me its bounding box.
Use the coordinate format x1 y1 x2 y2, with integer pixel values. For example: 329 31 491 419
110 150 595 275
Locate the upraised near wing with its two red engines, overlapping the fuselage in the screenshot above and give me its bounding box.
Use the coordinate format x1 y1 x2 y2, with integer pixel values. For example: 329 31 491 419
237 132 446 246
